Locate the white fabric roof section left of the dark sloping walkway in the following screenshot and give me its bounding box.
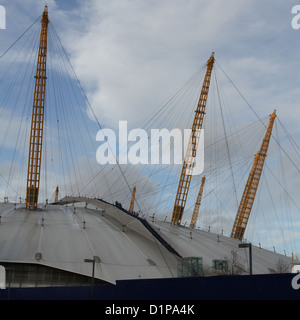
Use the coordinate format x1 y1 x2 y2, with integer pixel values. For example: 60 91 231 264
0 204 177 283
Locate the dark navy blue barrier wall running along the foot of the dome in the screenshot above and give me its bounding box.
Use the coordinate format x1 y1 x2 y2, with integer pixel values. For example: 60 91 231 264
0 273 300 301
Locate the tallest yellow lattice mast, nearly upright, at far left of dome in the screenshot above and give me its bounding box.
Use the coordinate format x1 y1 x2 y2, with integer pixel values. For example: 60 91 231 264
26 6 49 210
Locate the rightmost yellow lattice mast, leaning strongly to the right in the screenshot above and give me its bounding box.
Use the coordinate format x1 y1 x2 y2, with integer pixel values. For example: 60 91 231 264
231 110 276 240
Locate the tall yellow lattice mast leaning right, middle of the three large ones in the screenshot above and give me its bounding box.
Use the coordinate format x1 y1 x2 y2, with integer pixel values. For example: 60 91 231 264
171 52 215 224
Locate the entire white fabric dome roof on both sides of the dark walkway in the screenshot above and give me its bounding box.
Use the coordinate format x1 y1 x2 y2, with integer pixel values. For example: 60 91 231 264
0 198 291 283
